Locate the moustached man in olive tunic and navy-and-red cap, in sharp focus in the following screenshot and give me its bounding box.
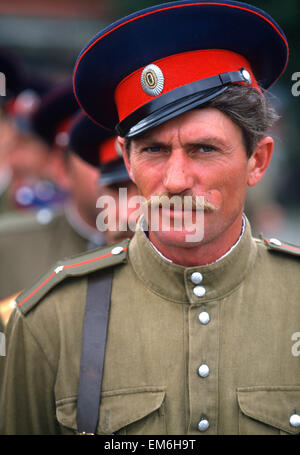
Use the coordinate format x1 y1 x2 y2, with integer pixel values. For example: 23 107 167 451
1 0 300 435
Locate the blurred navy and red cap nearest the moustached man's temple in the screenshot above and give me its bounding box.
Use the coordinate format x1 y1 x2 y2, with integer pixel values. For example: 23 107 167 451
69 111 130 185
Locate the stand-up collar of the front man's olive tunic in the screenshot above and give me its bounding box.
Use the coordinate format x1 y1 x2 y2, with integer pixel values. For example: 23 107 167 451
129 219 256 304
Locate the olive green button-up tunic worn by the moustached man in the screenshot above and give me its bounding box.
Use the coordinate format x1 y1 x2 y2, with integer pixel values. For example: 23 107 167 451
0 219 300 435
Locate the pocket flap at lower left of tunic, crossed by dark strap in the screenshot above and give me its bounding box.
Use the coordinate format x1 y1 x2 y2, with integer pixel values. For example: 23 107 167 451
56 387 165 434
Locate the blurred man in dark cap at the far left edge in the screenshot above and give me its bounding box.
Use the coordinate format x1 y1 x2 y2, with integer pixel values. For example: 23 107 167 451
0 49 51 214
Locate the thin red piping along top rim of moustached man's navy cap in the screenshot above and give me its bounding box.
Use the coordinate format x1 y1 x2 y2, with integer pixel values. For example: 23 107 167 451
73 2 289 128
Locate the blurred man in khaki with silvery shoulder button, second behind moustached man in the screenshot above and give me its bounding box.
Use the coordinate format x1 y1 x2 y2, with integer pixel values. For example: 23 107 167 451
0 84 100 318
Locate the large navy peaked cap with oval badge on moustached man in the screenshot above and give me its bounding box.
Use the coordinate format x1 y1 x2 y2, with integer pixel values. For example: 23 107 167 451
74 0 288 137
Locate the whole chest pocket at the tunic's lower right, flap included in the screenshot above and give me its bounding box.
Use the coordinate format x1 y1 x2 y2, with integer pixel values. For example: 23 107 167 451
237 386 300 435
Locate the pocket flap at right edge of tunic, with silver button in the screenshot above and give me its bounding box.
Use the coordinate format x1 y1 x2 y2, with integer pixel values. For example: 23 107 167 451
237 386 300 434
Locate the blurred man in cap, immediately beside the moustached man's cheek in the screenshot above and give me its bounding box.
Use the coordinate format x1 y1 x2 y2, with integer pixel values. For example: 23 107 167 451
70 113 139 245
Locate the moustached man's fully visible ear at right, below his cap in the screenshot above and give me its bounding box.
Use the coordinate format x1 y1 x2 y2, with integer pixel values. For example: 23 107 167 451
247 136 274 186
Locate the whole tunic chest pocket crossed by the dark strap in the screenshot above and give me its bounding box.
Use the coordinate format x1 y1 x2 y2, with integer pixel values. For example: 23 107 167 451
56 387 167 435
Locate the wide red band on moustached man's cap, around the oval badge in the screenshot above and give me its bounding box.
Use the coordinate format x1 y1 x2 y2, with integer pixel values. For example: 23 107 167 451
115 49 258 121
